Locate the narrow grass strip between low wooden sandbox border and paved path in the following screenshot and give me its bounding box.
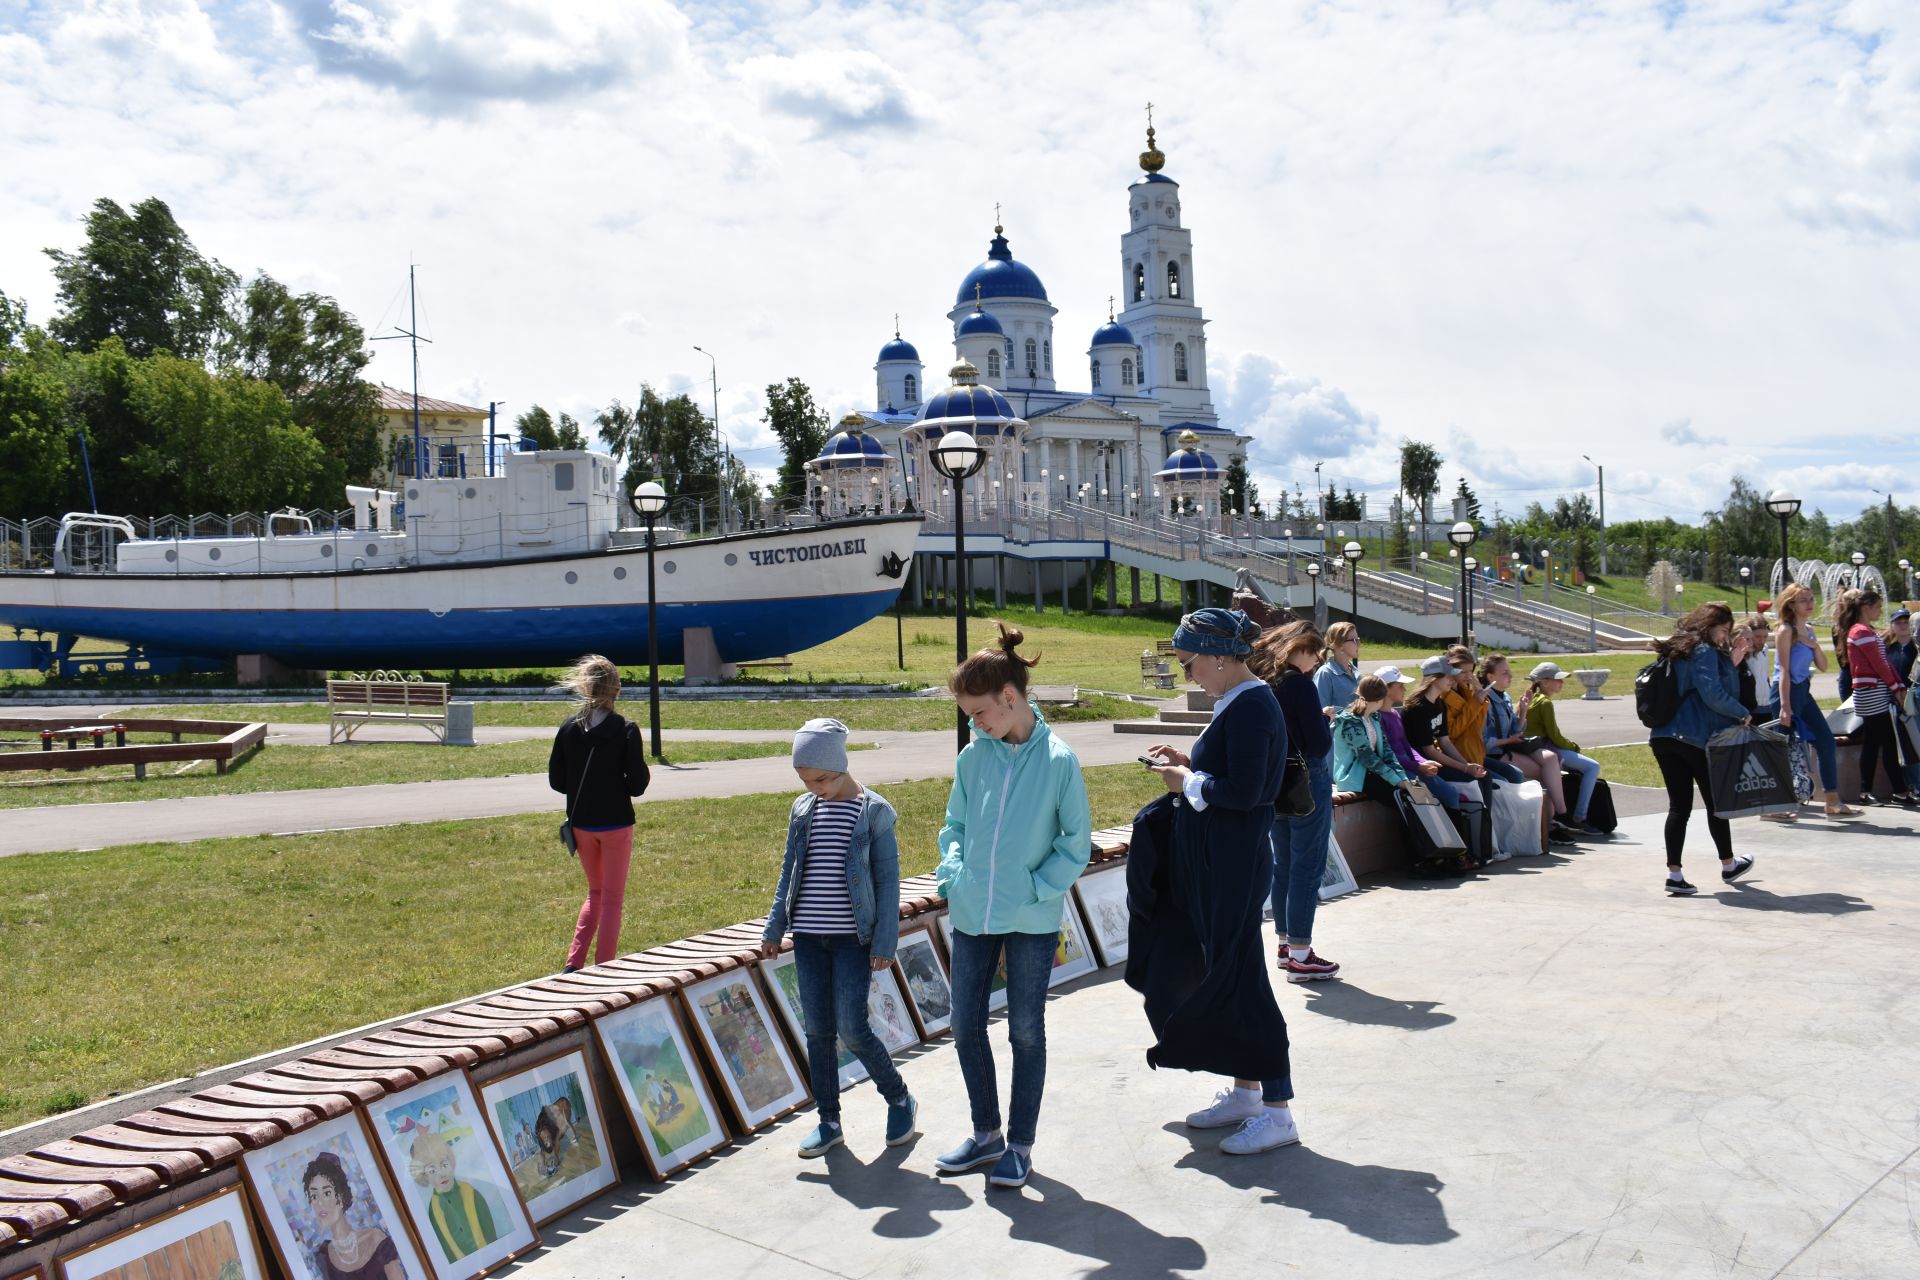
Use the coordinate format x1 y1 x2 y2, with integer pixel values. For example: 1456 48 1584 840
0 736 817 808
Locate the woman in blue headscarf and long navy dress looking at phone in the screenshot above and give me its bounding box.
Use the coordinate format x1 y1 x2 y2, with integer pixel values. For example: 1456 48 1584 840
1127 608 1300 1155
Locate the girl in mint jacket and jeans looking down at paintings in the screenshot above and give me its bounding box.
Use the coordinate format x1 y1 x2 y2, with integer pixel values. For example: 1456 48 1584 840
935 626 1092 1186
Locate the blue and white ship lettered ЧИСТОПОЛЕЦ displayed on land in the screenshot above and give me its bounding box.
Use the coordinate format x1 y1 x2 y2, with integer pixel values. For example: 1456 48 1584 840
0 449 922 668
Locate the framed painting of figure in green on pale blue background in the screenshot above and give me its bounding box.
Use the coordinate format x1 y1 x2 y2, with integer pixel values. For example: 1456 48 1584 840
367 1071 540 1280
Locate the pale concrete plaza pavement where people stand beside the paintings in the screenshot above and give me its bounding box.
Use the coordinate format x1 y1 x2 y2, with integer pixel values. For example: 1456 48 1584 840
505 810 1920 1280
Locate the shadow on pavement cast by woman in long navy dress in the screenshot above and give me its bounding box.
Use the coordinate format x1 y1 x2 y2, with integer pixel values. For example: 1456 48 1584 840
1164 1123 1459 1244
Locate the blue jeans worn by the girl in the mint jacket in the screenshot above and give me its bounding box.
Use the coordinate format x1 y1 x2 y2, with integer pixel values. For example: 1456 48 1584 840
952 929 1060 1146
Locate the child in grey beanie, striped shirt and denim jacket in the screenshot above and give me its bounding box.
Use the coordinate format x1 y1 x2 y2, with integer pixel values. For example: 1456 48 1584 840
760 720 920 1159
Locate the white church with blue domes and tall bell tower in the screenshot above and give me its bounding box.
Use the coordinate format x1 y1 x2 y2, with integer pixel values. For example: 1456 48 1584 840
810 127 1250 516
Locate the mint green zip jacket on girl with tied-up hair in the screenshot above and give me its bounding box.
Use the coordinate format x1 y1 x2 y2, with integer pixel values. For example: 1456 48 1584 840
935 706 1092 936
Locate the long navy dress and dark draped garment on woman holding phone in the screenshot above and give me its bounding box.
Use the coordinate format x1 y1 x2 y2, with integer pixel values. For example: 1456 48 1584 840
1127 683 1292 1080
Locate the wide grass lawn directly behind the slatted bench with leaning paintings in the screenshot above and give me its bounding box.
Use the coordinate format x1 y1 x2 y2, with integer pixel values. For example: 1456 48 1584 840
0 764 1160 1128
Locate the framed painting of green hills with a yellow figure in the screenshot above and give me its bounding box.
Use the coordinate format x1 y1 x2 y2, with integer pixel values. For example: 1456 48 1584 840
593 996 733 1180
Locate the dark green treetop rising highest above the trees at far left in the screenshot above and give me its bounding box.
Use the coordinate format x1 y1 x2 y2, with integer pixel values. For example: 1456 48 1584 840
46 196 240 359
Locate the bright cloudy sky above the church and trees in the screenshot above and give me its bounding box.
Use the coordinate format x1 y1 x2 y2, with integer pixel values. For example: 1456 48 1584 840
0 0 1920 522
